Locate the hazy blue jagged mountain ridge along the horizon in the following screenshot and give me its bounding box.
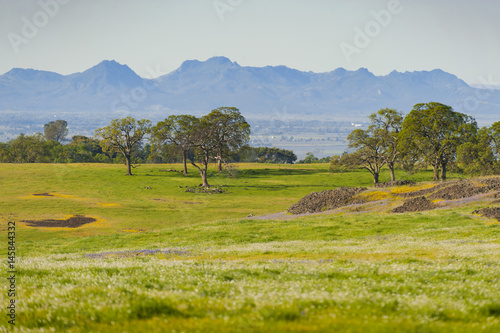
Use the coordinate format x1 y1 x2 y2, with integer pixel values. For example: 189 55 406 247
0 57 500 119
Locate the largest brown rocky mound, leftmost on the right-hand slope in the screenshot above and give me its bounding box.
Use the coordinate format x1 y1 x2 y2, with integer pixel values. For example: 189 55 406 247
288 187 366 214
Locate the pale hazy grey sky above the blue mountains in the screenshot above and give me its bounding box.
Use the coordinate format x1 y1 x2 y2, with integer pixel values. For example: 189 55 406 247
0 0 500 84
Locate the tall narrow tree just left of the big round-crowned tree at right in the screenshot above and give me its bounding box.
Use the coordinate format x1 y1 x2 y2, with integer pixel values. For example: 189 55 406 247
370 109 403 181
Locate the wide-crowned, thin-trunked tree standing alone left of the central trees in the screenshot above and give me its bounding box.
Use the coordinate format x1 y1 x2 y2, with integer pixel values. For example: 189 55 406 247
95 117 151 176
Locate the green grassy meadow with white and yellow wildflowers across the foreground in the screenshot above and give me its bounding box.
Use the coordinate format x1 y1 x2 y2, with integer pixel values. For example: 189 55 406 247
0 164 500 332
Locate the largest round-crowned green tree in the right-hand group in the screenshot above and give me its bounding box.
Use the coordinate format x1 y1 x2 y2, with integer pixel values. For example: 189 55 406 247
400 102 477 181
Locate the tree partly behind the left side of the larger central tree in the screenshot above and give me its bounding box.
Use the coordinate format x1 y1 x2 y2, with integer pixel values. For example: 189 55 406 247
151 115 198 175
